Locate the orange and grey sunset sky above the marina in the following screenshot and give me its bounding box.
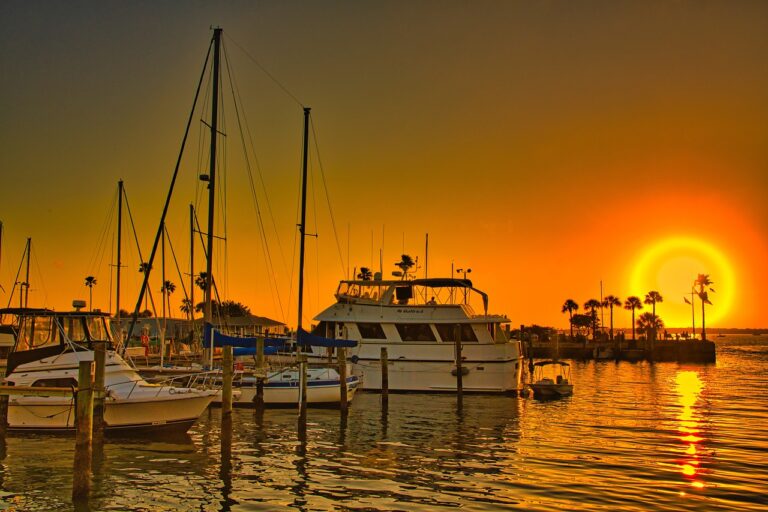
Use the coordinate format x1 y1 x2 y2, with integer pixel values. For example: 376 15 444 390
0 2 768 328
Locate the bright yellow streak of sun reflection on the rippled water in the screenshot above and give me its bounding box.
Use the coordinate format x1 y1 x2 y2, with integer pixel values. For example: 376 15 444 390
675 371 704 489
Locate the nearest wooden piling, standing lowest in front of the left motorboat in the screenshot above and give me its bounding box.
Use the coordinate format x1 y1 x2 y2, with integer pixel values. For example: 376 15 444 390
72 361 93 500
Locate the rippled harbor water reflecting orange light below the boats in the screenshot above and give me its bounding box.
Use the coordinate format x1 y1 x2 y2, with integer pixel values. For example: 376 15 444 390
0 336 768 511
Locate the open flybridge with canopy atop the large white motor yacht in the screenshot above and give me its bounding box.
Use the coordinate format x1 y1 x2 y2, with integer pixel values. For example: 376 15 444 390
336 278 488 314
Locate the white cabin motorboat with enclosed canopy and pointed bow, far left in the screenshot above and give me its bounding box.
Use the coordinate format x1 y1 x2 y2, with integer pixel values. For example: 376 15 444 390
0 308 217 432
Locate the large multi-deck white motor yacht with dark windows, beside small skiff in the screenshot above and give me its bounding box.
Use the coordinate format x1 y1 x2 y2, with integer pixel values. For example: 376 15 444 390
312 274 523 393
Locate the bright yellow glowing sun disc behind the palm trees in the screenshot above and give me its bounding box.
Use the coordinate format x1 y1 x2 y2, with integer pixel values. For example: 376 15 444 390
630 237 736 329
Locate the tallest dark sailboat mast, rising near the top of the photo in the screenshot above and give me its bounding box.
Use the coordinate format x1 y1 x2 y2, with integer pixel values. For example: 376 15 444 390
205 28 221 326
